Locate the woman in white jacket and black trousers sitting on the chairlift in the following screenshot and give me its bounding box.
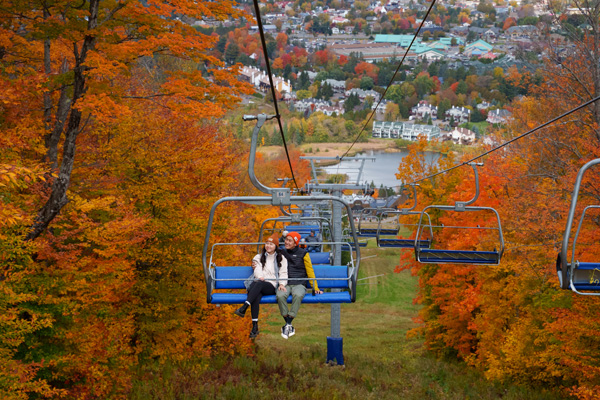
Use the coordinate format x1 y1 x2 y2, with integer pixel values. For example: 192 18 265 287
235 233 288 338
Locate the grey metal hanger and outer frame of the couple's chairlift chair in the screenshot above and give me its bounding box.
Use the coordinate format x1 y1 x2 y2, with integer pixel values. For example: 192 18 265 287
202 114 360 304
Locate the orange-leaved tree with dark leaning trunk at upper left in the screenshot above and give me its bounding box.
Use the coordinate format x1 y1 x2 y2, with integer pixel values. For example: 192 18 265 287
0 0 251 240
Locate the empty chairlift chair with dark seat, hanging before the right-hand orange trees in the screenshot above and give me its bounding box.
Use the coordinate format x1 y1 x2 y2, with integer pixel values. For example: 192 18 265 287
415 163 504 265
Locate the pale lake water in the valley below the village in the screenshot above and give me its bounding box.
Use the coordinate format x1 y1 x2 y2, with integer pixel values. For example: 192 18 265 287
323 150 440 188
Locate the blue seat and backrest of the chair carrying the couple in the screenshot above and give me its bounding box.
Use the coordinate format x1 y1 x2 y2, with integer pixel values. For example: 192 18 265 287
210 265 352 304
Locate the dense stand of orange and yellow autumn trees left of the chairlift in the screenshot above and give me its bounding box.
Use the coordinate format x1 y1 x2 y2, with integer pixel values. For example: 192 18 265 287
0 0 264 398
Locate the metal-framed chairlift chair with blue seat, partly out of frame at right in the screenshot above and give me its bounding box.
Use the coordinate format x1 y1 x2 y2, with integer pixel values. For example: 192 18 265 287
556 158 600 296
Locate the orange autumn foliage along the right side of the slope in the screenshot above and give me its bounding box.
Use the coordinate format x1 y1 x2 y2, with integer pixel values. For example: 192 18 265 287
397 39 600 399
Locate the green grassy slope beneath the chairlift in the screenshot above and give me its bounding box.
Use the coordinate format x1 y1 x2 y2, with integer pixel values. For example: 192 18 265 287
131 248 563 400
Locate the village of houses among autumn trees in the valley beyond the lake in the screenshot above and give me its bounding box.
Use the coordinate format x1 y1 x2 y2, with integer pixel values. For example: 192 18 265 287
192 0 585 144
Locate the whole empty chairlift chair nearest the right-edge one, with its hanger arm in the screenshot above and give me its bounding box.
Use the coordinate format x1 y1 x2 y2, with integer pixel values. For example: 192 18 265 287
415 163 504 264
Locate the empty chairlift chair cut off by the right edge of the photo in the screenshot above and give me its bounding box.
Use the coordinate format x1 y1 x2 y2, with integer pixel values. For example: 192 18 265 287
556 158 600 296
